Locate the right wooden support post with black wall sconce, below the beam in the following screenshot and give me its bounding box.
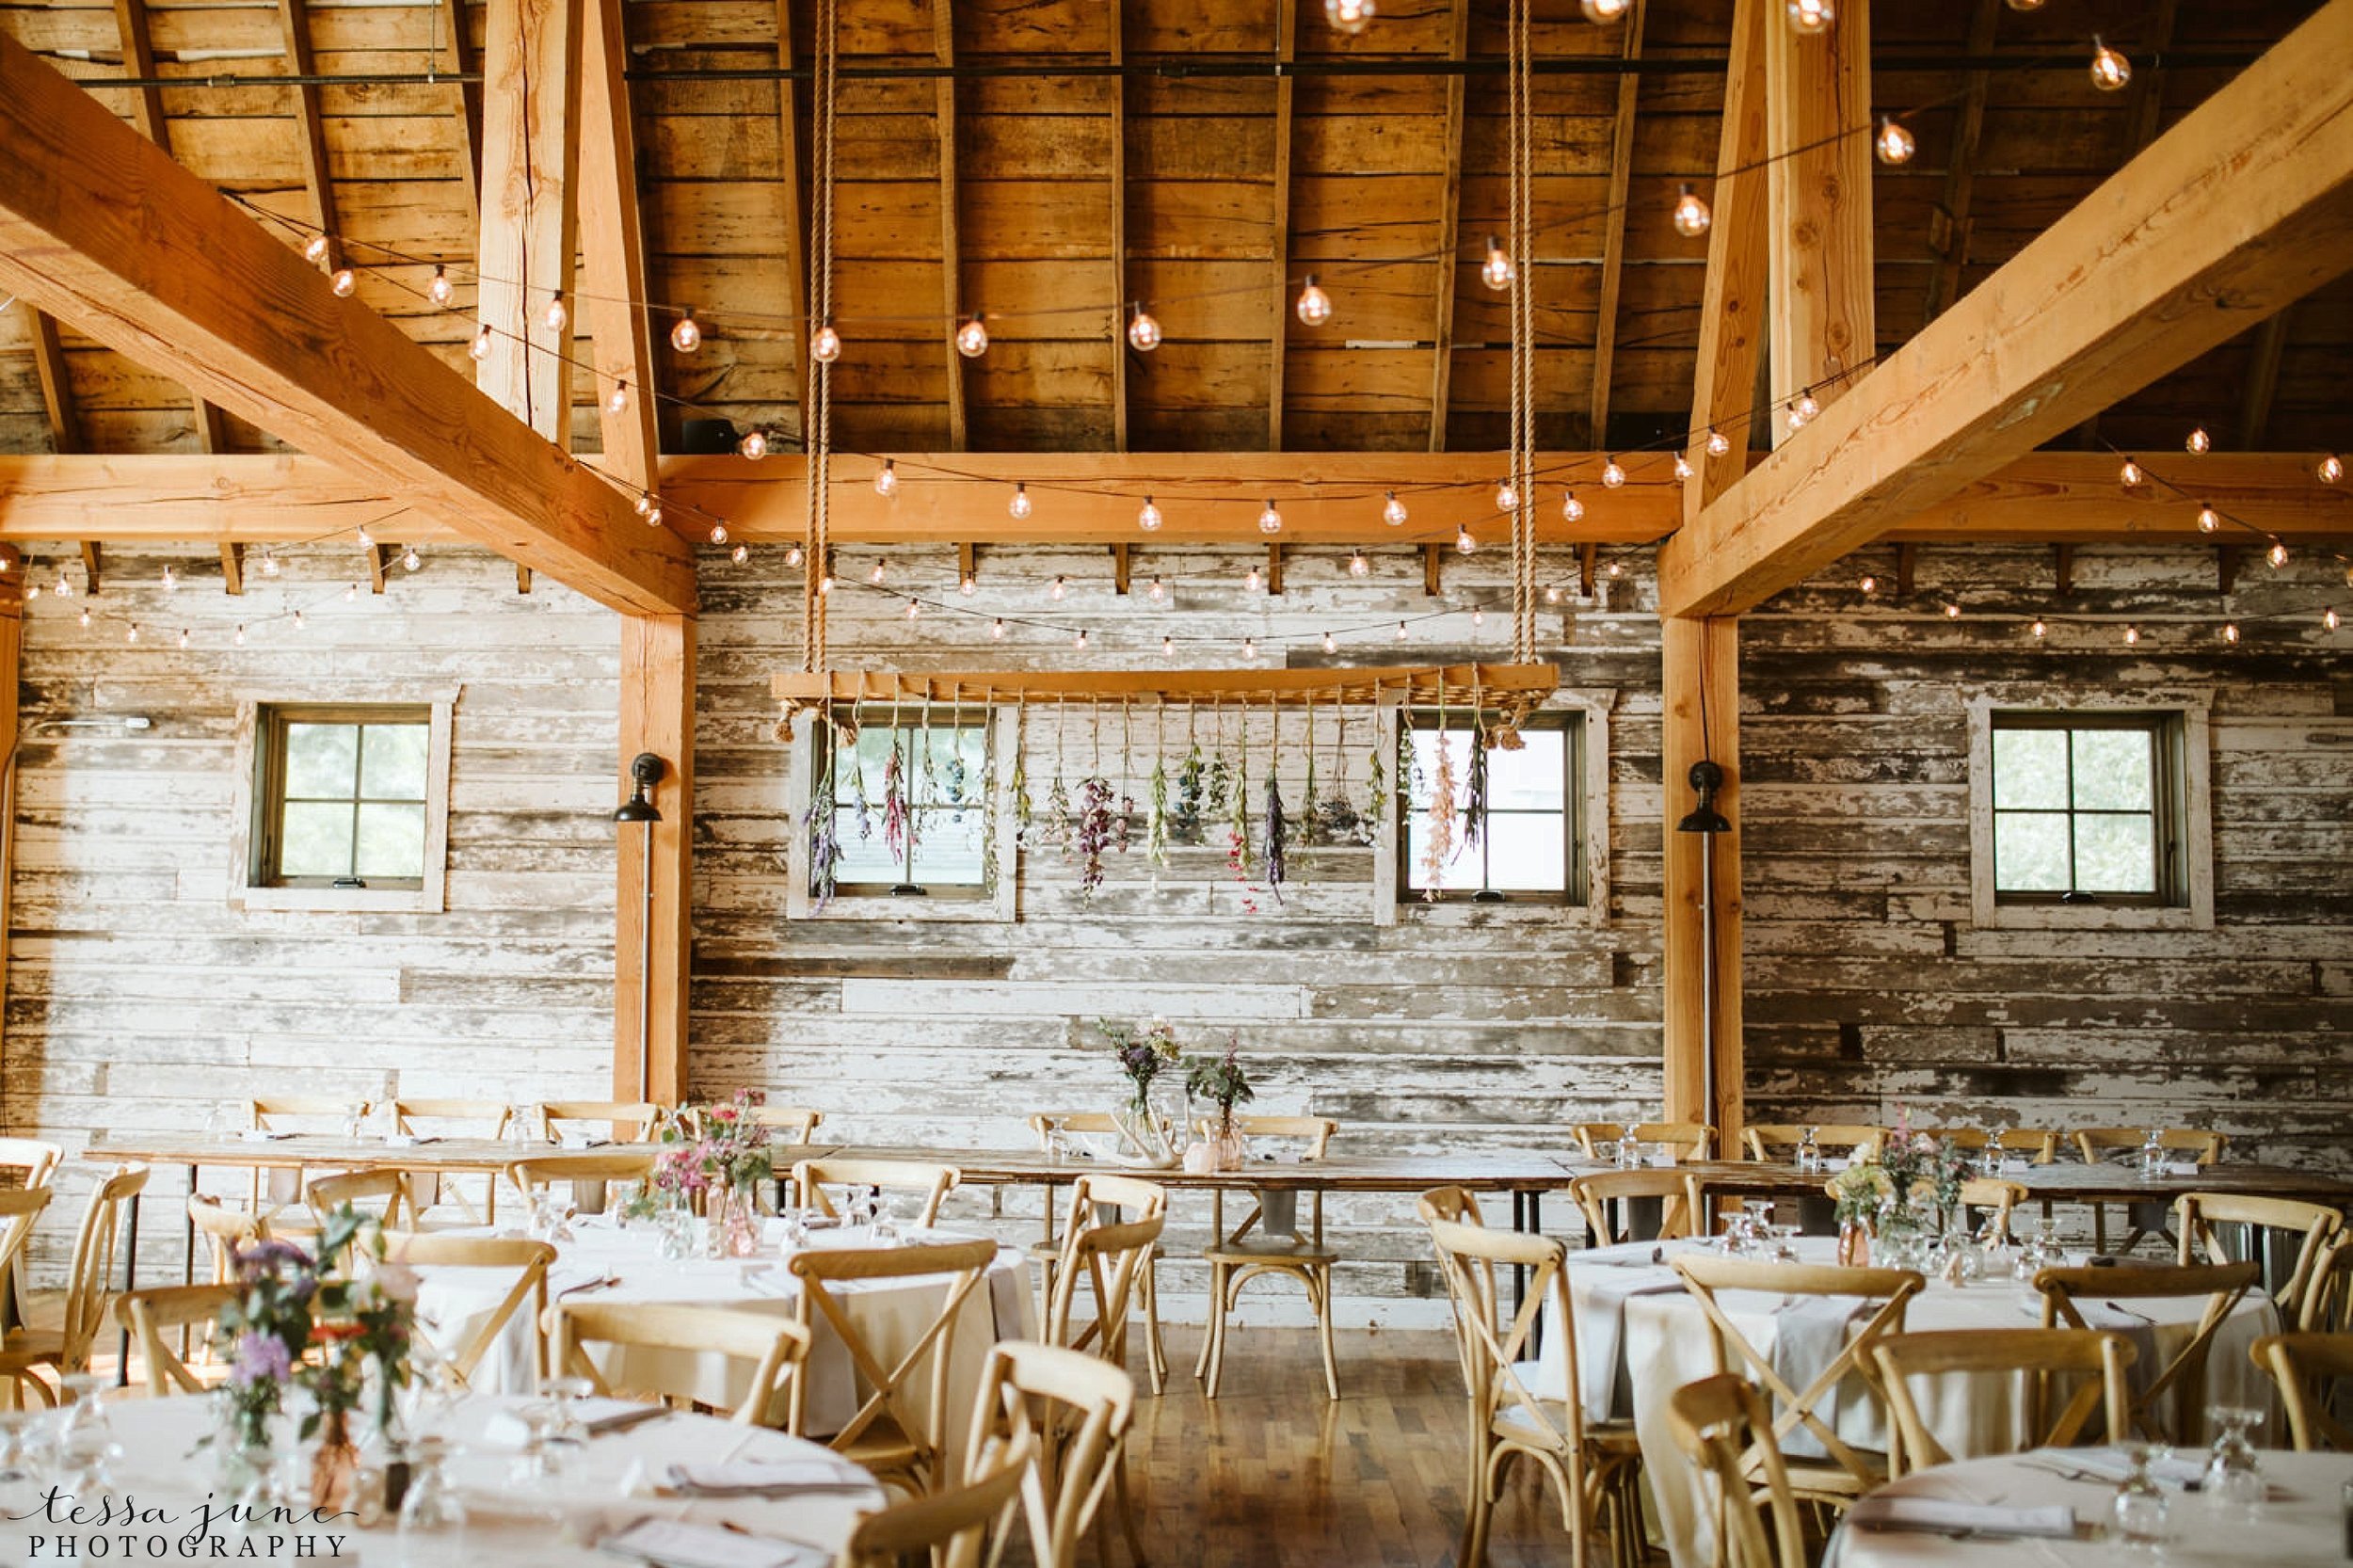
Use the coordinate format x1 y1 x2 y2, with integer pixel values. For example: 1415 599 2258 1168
1661 619 1744 1149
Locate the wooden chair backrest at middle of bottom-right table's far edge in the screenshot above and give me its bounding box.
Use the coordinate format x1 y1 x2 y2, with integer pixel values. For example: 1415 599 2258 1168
1871 1328 2135 1476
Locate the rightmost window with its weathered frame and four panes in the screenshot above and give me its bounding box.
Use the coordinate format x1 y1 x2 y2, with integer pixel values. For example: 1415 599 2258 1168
1970 704 2215 928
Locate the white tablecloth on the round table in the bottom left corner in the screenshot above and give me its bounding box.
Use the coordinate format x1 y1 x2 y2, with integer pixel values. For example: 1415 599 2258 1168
0 1396 883 1568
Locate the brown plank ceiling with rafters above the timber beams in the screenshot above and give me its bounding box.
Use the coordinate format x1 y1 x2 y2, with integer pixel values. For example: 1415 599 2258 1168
0 0 2353 463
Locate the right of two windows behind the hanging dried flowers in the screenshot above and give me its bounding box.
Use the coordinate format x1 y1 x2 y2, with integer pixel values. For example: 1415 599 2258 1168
1398 711 1586 904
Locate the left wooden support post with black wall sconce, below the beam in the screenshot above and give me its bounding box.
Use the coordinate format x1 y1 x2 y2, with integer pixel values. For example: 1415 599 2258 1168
612 615 695 1104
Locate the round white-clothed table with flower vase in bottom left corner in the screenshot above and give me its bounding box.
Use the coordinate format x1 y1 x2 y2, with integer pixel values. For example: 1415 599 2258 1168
0 1394 885 1568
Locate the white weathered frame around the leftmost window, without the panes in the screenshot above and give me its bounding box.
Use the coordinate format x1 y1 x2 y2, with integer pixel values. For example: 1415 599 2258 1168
229 692 456 914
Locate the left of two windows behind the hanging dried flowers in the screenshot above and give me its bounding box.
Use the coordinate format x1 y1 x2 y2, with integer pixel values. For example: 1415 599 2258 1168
819 706 993 900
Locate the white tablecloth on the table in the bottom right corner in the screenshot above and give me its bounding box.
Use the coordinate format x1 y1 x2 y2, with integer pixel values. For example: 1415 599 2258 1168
1824 1448 2353 1568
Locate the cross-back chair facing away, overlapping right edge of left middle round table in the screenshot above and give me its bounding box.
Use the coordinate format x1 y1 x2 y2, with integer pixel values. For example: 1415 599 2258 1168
784 1240 998 1493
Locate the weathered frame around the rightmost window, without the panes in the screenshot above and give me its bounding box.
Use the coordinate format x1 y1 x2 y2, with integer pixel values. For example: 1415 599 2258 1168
1970 690 2215 930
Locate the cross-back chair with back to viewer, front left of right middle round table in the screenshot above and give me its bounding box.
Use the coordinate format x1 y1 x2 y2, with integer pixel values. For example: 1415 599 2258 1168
1675 1253 1925 1509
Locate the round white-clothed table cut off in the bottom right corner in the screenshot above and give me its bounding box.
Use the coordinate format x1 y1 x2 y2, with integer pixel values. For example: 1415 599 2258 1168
1821 1448 2353 1568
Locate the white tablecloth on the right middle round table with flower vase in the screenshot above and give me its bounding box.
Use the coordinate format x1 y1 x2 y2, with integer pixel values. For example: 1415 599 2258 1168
1529 1236 2278 1568
